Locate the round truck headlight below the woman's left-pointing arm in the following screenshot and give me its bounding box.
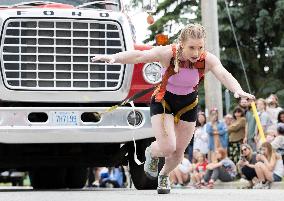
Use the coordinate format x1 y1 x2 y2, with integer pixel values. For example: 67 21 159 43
142 62 162 84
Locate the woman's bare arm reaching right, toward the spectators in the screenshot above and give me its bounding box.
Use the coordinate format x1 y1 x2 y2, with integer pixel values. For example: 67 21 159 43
205 52 255 99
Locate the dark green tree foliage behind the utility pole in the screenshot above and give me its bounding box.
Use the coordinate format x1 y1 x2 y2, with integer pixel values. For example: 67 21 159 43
142 0 284 107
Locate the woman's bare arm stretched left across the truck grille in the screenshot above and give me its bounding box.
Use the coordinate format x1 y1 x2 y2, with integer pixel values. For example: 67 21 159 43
91 46 170 64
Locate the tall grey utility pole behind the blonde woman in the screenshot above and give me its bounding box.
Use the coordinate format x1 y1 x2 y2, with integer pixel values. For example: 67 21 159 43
201 0 223 119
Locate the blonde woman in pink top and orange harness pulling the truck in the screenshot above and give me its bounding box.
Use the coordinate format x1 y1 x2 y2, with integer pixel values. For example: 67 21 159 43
92 24 254 193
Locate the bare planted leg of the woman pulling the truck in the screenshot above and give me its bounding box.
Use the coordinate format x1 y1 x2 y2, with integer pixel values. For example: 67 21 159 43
159 120 195 175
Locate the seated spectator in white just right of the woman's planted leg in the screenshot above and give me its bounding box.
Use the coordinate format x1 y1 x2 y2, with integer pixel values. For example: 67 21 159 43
170 157 191 187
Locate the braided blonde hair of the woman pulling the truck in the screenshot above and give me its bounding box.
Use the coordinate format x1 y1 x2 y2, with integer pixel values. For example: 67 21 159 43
174 24 206 73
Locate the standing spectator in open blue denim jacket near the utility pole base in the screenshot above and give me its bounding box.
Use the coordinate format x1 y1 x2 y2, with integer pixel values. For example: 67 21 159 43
206 108 228 162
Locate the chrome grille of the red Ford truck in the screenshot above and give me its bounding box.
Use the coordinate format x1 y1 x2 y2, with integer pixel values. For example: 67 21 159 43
0 19 125 90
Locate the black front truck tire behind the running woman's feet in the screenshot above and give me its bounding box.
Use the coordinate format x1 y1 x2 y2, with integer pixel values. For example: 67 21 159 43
128 138 164 190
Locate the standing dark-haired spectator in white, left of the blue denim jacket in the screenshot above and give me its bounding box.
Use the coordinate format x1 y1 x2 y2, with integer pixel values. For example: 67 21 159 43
193 112 208 155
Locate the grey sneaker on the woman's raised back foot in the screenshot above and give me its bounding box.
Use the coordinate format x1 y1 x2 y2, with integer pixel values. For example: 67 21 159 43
144 147 159 180
